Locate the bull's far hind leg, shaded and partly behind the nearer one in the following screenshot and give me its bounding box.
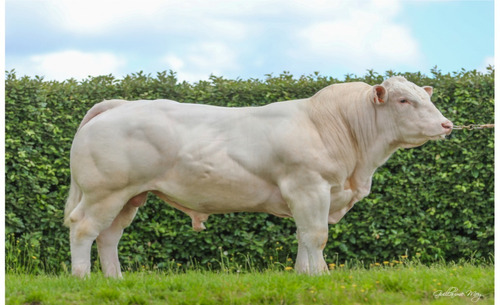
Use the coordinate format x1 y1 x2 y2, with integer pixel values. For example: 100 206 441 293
97 193 147 277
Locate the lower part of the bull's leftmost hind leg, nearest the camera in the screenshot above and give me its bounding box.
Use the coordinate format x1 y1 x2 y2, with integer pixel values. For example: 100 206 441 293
69 195 129 277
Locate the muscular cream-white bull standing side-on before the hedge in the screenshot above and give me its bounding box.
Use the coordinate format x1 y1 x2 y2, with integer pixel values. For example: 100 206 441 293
65 77 453 277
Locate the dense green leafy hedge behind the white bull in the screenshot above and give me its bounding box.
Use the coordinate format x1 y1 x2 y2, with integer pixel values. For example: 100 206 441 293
5 69 494 271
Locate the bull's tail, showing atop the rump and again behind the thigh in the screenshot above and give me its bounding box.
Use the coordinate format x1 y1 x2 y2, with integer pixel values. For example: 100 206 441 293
64 100 126 227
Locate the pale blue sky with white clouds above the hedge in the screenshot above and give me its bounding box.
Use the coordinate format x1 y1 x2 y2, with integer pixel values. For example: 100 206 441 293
5 0 494 82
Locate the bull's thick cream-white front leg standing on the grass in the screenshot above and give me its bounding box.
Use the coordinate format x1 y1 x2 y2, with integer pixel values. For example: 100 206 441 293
280 175 330 274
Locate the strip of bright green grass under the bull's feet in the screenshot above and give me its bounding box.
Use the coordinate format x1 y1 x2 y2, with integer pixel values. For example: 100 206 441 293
5 262 494 305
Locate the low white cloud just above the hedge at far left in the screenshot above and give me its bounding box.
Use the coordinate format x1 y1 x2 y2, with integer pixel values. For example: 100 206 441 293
14 50 125 80
